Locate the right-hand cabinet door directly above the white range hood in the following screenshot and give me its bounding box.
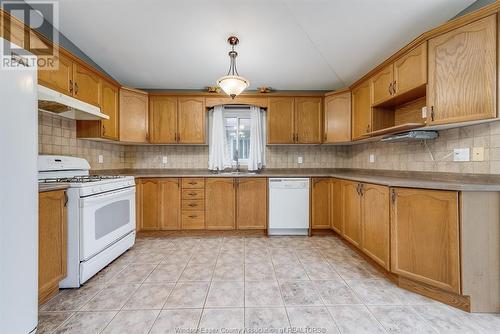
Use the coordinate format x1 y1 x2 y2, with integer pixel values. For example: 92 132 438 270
73 63 101 106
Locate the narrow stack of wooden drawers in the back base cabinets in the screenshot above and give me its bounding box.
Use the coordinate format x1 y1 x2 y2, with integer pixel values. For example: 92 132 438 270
181 178 205 229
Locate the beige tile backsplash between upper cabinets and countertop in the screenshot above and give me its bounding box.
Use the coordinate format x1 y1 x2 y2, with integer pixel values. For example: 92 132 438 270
39 112 500 174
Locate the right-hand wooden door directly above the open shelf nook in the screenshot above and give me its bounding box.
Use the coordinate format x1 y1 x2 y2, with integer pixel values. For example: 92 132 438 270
394 42 427 96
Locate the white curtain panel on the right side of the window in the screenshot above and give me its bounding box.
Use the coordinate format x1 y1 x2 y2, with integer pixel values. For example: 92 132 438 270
248 106 265 170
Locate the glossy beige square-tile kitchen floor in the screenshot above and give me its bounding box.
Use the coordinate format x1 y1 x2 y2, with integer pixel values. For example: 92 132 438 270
38 236 500 334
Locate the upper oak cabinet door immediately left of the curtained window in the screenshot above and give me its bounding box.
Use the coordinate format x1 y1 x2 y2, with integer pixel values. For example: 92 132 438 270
177 97 207 144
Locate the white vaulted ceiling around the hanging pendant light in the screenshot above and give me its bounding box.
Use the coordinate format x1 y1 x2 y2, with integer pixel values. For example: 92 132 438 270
51 0 474 90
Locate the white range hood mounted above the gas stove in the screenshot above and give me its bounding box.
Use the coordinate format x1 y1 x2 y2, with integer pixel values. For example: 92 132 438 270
38 85 109 120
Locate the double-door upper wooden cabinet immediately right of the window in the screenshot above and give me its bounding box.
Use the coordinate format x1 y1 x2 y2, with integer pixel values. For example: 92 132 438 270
267 97 323 144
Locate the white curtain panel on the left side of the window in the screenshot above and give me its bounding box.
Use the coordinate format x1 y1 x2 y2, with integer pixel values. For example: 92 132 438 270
208 106 226 170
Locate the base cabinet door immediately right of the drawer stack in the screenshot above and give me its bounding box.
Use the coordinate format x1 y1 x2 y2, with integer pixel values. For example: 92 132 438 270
205 177 236 230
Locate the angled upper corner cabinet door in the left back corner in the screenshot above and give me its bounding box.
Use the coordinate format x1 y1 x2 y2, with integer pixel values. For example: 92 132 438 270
119 87 149 143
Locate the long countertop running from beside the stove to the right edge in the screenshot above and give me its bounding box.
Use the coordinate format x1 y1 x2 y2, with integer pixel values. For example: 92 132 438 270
92 168 500 191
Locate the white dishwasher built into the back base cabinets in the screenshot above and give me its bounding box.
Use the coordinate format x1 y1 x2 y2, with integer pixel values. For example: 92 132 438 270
268 178 309 235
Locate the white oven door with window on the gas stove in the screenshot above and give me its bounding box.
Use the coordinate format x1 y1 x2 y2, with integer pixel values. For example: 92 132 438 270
80 187 135 261
